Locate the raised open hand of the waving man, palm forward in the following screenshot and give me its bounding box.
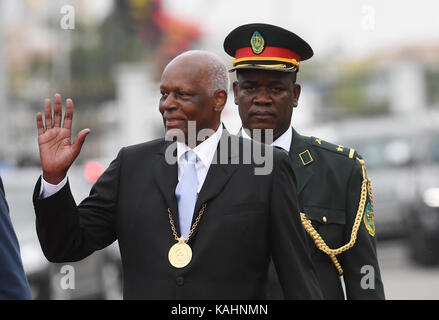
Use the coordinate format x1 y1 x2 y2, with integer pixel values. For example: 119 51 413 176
37 94 90 184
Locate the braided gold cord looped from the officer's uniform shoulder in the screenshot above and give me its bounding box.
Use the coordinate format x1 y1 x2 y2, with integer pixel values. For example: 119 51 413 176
300 157 373 276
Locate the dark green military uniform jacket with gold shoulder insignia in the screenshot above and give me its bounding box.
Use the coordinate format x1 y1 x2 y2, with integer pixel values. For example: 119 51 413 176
270 129 384 299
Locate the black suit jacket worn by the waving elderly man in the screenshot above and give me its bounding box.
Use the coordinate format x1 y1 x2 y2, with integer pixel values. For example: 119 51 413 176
34 130 321 299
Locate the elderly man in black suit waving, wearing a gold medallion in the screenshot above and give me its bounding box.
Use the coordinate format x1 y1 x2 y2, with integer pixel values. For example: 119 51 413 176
34 51 321 299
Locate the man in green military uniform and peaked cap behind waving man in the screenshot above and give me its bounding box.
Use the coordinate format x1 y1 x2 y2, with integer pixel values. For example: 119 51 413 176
224 23 384 299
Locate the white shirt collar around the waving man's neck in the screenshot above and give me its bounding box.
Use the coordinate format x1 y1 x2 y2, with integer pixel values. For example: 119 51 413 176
177 123 223 167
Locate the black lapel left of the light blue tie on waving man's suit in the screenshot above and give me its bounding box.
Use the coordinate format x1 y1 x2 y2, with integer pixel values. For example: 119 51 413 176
153 142 180 230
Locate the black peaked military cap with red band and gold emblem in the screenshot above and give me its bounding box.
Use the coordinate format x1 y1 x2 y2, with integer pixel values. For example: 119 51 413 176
224 23 314 72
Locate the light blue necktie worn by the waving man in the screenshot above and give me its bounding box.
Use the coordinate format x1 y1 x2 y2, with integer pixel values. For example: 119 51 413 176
175 150 198 238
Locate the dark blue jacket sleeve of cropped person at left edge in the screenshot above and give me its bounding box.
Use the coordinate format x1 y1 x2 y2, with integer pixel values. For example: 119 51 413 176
0 177 31 300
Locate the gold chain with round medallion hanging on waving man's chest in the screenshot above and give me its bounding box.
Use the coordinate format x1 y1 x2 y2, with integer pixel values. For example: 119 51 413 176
168 203 207 268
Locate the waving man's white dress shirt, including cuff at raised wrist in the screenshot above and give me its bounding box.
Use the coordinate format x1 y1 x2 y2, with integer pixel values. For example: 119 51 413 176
40 124 223 198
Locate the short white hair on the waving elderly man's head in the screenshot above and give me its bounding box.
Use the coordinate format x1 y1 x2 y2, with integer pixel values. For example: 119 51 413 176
165 50 229 94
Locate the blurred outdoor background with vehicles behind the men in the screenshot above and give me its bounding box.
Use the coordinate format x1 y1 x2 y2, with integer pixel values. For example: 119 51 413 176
0 0 439 299
